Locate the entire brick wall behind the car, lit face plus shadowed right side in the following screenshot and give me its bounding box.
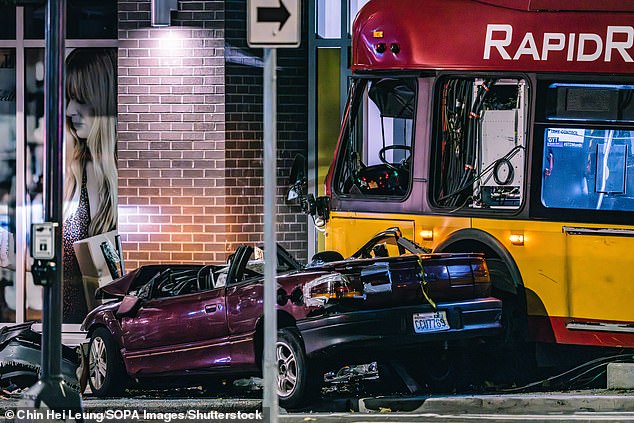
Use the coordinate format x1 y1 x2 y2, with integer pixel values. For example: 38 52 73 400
118 0 307 269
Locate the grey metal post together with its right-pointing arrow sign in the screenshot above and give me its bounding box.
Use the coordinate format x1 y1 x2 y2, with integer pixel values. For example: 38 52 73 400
247 0 301 423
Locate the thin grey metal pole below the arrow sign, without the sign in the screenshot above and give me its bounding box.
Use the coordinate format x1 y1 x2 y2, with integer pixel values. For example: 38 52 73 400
262 48 277 423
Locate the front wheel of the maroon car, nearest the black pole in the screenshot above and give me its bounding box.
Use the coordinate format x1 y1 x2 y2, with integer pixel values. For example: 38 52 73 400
88 328 127 397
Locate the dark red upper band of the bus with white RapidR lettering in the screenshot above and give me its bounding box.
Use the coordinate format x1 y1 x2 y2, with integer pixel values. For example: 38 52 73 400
352 0 634 74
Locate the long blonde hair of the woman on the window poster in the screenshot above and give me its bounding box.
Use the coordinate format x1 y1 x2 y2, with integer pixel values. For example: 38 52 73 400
64 48 117 236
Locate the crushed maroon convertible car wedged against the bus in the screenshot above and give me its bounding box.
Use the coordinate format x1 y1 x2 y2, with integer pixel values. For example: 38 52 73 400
82 228 502 408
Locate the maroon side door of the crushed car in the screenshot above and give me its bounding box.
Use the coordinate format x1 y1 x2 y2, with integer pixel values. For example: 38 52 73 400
121 270 231 374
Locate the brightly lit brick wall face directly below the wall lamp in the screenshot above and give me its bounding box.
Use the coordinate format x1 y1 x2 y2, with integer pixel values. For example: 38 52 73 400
118 0 226 269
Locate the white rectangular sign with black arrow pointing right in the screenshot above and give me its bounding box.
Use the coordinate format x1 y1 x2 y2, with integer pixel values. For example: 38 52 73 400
247 0 301 48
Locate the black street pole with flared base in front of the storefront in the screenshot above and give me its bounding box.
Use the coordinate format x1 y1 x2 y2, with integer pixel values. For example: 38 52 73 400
23 0 81 410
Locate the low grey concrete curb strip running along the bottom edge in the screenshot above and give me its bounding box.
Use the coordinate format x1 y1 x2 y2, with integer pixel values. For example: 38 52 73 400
0 390 634 417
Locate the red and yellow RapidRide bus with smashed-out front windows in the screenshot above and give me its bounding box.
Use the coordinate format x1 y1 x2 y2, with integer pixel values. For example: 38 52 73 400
318 0 634 356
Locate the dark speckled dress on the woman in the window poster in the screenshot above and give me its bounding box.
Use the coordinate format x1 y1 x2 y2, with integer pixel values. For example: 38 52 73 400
62 170 90 323
